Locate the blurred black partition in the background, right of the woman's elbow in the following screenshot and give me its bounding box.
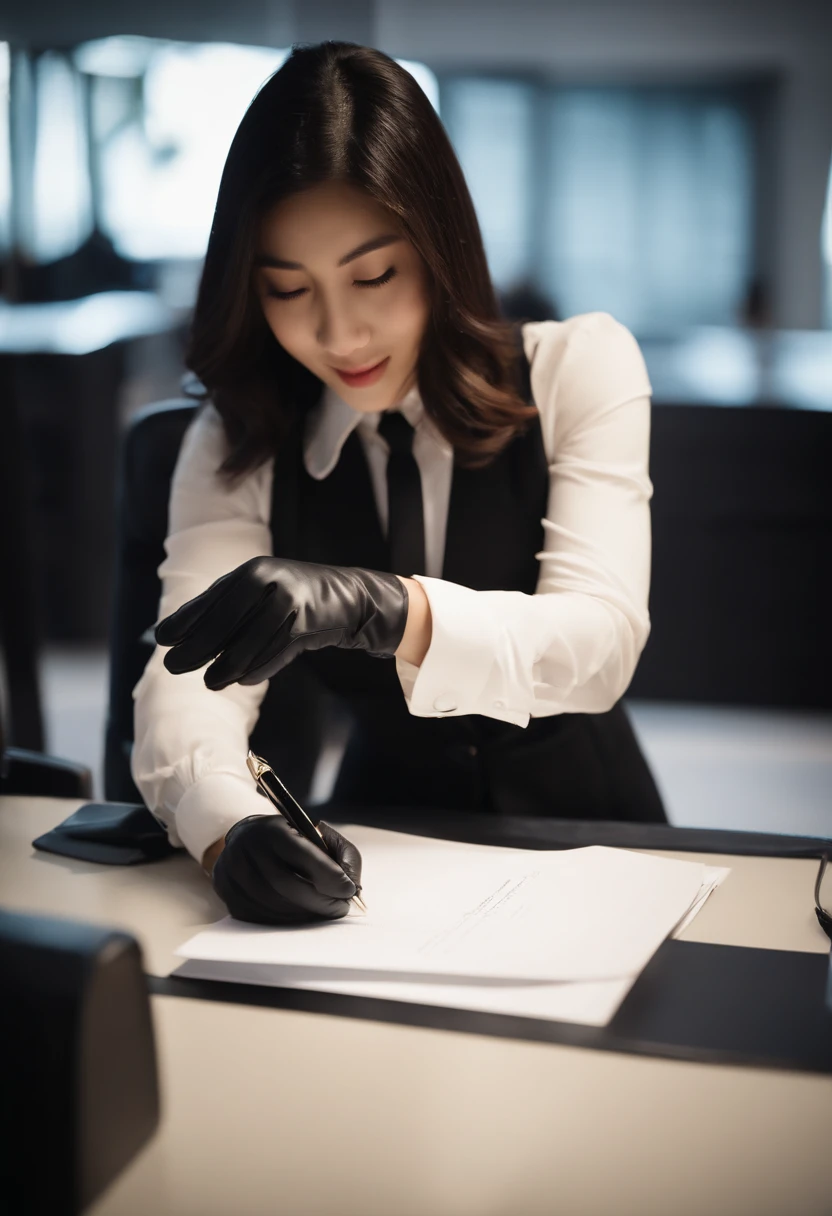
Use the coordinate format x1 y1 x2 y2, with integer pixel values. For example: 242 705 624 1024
629 405 832 710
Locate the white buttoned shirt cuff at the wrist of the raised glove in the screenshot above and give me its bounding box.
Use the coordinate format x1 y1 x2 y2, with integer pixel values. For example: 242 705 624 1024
397 574 530 726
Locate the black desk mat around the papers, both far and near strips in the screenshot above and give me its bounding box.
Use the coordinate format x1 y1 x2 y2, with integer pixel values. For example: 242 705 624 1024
148 804 832 1074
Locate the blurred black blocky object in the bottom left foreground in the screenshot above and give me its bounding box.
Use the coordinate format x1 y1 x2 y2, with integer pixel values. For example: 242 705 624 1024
0 911 159 1216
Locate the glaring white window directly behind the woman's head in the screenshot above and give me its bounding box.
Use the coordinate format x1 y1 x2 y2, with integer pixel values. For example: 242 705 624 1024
75 36 438 260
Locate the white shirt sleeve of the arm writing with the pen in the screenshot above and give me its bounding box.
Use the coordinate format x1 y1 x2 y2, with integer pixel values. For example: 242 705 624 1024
131 406 272 861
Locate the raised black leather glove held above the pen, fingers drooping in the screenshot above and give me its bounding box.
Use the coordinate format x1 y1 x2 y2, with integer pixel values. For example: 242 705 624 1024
156 557 407 689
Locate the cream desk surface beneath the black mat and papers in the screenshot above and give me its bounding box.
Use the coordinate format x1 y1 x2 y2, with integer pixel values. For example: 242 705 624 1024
0 798 832 1216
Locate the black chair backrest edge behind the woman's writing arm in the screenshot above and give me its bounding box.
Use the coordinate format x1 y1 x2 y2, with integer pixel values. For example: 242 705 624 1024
103 399 197 803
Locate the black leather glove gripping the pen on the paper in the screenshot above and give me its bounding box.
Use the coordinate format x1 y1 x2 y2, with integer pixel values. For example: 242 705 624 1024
210 815 361 924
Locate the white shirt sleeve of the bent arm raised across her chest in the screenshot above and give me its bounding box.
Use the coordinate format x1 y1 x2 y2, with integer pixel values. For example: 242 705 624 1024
397 313 653 726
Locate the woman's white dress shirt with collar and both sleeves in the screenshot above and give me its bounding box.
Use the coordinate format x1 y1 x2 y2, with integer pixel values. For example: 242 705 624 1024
131 313 652 860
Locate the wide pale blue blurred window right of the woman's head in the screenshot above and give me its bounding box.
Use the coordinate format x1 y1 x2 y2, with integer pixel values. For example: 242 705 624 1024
442 78 755 332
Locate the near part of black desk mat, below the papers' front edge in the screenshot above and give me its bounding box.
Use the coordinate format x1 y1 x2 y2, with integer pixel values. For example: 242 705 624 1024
148 940 832 1074
